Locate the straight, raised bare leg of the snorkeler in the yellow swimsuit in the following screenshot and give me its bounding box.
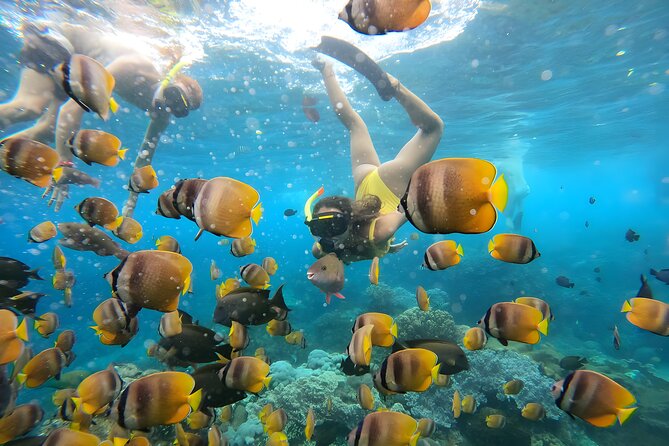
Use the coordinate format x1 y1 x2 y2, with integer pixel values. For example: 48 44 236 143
313 59 381 186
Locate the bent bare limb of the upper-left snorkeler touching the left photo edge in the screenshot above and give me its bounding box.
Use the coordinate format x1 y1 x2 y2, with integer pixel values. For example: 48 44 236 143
0 68 54 130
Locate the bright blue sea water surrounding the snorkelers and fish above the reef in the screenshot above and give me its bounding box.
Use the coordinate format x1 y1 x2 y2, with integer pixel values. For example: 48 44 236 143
0 0 669 445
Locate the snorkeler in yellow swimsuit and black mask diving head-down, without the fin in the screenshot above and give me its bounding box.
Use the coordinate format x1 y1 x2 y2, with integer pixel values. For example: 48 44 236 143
305 51 444 263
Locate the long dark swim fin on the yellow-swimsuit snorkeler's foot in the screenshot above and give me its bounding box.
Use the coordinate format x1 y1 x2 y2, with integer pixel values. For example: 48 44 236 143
314 36 395 101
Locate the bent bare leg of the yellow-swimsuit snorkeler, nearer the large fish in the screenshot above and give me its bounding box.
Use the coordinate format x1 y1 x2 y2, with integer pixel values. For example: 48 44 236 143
379 75 444 197
